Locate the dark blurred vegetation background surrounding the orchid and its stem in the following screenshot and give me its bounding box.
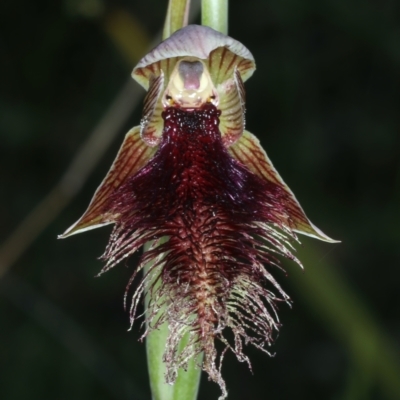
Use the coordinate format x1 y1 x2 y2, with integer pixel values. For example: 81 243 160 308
0 0 400 400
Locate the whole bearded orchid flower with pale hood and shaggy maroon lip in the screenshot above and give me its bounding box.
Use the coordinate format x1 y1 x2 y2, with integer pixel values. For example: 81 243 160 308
62 25 333 398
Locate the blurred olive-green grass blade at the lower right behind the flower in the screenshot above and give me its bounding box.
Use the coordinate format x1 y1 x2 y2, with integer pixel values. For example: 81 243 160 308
289 240 400 399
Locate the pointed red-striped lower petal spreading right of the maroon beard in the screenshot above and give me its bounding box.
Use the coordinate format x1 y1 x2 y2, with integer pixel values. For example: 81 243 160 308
228 131 338 243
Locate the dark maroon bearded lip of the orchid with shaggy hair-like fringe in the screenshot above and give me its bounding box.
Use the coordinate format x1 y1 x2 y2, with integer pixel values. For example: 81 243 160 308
103 104 295 392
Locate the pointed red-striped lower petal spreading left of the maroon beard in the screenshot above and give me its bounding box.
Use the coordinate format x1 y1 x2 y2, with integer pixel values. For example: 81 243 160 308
59 126 156 238
